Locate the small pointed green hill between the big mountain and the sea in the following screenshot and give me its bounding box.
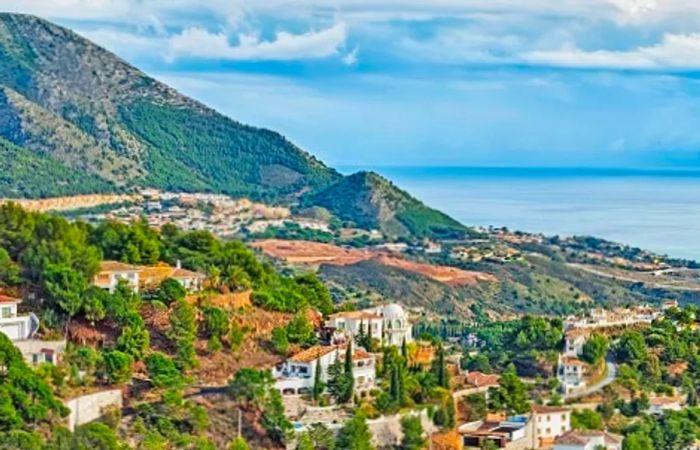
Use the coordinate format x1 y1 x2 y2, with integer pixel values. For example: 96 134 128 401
306 172 468 238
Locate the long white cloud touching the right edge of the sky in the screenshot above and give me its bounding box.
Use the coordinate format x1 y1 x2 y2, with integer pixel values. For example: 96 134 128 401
521 33 700 70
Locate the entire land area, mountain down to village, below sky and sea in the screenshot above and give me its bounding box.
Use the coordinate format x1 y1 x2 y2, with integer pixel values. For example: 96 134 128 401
0 8 700 450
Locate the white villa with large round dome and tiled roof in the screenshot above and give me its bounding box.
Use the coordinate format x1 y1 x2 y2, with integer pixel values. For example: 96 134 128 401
326 303 413 346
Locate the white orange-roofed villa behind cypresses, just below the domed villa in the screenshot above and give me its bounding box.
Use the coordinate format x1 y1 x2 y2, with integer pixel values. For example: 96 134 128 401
272 345 376 395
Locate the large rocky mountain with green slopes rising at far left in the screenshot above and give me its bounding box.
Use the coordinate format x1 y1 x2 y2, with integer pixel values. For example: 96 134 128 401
0 14 341 202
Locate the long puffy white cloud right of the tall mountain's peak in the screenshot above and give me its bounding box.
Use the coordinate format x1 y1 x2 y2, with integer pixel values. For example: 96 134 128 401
168 22 347 61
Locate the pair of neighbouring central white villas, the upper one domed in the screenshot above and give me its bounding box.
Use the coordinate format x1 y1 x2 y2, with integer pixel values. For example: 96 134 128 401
272 303 413 395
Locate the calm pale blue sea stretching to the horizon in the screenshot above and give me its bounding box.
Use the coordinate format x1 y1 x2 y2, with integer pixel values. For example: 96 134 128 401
343 167 700 260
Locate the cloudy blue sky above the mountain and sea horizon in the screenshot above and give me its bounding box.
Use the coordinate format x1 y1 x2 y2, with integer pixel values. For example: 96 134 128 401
0 0 700 167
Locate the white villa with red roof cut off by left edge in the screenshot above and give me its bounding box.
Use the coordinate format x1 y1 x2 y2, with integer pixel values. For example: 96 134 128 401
0 295 66 366
